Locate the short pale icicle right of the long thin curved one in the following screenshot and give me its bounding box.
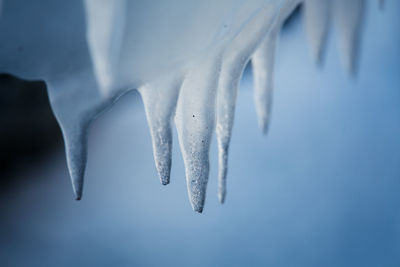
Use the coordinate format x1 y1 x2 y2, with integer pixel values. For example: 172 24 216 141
251 27 280 134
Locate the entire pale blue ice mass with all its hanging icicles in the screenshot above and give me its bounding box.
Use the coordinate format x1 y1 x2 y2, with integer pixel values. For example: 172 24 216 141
0 0 376 212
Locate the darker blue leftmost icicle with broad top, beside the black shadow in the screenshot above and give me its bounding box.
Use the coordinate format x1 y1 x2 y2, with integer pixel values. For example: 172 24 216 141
46 70 108 200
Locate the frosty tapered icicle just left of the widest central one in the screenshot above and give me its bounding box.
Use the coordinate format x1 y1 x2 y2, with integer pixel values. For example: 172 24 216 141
138 76 181 185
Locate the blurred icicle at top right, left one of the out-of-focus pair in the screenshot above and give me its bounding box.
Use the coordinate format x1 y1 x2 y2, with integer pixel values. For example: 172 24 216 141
303 0 331 64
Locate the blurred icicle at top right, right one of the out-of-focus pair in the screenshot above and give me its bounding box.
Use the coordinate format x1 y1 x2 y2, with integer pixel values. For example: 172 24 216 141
334 0 364 74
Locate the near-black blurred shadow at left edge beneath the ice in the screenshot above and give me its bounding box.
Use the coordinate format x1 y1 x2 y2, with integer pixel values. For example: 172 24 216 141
0 74 62 192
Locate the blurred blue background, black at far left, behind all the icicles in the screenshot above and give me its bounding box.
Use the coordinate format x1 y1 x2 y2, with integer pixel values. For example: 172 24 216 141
0 0 400 266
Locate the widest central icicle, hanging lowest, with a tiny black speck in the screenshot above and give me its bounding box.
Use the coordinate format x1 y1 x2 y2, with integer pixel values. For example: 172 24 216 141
175 53 221 213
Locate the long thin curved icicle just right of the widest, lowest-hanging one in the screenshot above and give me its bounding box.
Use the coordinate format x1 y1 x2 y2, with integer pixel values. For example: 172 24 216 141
216 3 281 203
